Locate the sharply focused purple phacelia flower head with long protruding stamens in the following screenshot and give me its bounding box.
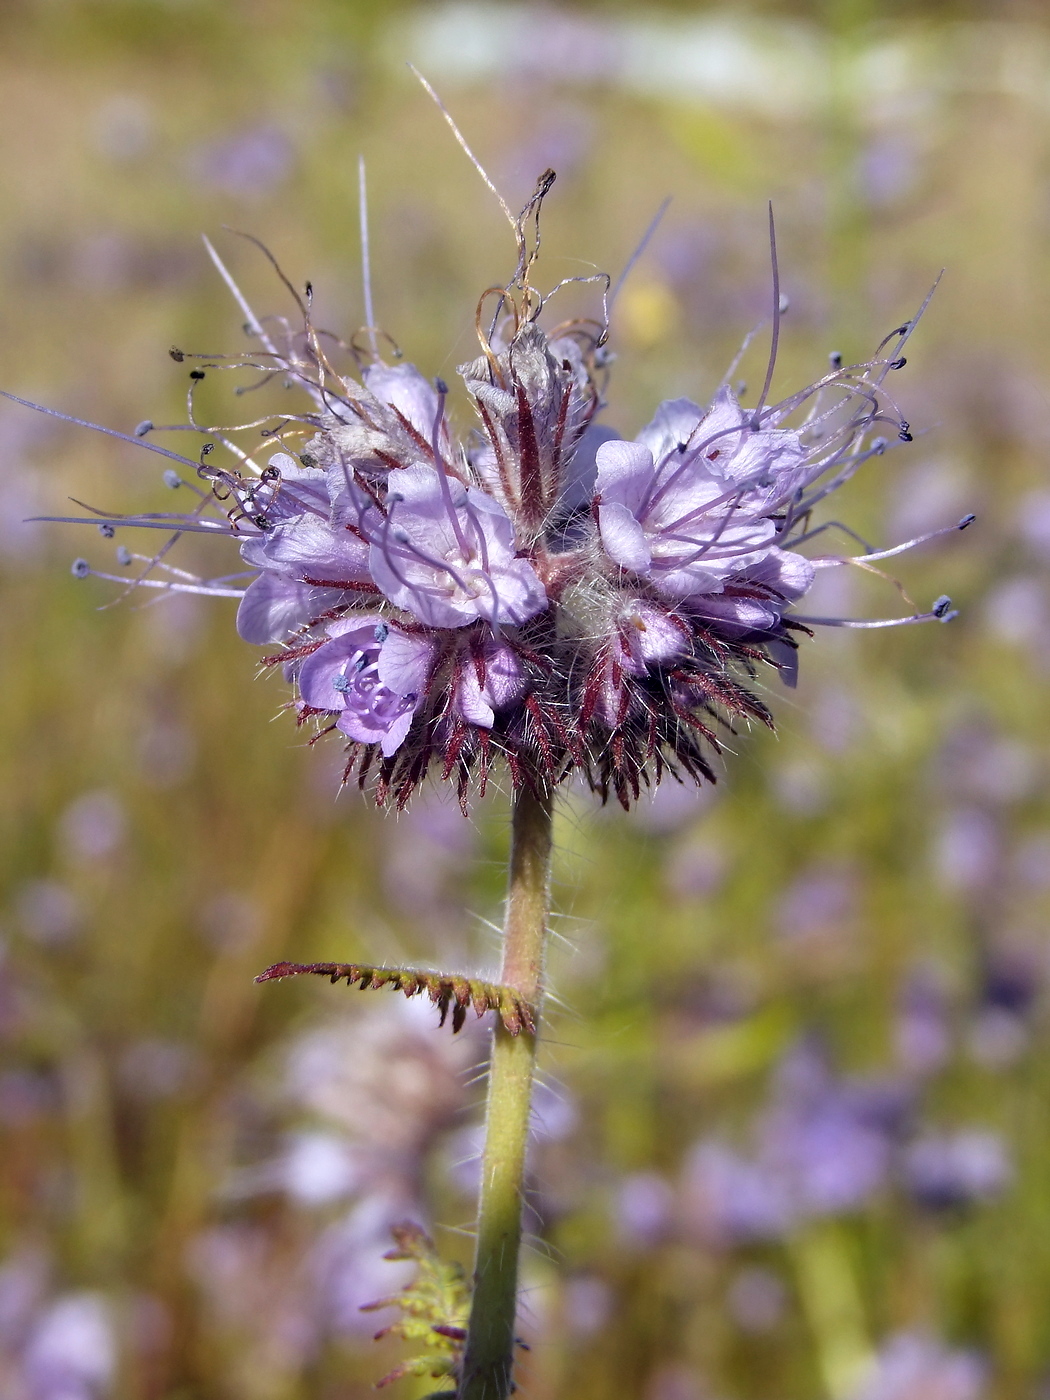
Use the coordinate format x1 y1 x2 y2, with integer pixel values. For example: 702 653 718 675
26 186 969 806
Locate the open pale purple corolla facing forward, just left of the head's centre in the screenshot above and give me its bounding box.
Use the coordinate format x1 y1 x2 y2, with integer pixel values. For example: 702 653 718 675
363 465 547 627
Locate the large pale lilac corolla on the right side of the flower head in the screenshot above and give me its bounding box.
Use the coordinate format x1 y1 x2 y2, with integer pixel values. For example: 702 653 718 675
596 389 813 618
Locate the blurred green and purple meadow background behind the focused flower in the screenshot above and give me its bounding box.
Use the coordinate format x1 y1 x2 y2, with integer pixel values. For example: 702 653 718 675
0 0 1050 1400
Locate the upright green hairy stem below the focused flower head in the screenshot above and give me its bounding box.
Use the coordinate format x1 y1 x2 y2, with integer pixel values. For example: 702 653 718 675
458 788 552 1400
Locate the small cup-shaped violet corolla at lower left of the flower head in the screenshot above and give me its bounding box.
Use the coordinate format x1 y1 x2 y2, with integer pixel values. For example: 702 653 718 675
298 613 434 757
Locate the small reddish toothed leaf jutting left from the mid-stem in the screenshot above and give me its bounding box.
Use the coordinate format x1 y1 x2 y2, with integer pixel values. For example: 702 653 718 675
255 962 536 1036
